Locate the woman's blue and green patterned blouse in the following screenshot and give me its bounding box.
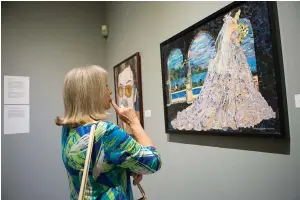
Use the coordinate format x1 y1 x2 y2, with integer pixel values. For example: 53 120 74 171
62 121 161 200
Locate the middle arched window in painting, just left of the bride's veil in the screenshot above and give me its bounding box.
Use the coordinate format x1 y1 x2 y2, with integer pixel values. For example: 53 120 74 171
188 31 216 98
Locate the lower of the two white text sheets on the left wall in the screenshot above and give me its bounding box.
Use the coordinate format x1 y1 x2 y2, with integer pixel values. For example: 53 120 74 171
3 105 30 134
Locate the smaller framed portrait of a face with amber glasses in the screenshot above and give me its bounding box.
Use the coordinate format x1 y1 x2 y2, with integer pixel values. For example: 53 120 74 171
114 52 144 134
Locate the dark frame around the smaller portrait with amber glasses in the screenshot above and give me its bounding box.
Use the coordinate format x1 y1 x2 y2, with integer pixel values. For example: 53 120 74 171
113 52 144 131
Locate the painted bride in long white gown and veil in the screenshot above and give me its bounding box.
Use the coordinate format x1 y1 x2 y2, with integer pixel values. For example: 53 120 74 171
171 10 276 131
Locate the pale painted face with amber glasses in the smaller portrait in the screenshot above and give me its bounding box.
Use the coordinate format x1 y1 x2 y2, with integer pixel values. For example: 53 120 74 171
118 66 134 108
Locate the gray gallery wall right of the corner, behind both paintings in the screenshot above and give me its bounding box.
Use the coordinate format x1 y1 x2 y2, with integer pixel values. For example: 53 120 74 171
105 2 300 200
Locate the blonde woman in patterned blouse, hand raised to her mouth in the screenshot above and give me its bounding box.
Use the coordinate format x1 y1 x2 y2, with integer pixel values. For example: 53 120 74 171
56 66 161 200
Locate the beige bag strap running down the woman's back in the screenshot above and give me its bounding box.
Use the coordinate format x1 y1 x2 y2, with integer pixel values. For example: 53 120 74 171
78 124 96 200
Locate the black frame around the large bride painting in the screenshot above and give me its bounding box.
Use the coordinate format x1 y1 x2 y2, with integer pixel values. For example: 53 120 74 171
160 2 289 138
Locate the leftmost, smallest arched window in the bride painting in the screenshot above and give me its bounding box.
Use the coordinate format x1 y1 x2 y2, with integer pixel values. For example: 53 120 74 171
167 48 186 103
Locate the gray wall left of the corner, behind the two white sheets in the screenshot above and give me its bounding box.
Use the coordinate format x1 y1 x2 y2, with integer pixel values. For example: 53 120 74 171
1 2 105 200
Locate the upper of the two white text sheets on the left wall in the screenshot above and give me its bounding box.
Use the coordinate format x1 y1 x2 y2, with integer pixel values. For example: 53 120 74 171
4 76 29 104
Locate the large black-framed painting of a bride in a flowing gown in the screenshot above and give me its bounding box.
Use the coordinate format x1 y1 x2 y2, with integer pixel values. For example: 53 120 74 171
160 1 289 137
